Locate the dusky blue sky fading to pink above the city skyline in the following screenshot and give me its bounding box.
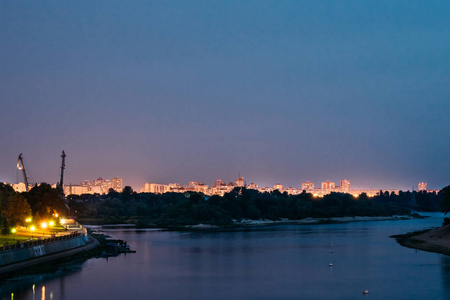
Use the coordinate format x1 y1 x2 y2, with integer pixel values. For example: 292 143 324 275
0 0 450 190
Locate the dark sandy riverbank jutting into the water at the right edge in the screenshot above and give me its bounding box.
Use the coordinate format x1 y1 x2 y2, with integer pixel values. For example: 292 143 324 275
392 224 450 255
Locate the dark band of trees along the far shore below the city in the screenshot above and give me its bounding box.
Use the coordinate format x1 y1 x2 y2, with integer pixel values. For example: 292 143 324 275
69 188 441 226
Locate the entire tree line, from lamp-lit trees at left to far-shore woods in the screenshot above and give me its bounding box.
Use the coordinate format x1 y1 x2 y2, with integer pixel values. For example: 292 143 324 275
0 183 450 233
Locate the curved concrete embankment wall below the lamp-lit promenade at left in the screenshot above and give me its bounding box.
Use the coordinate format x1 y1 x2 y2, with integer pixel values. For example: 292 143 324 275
0 233 99 276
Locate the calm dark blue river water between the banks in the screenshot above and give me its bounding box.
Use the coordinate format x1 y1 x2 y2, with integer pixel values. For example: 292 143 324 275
0 214 450 300
